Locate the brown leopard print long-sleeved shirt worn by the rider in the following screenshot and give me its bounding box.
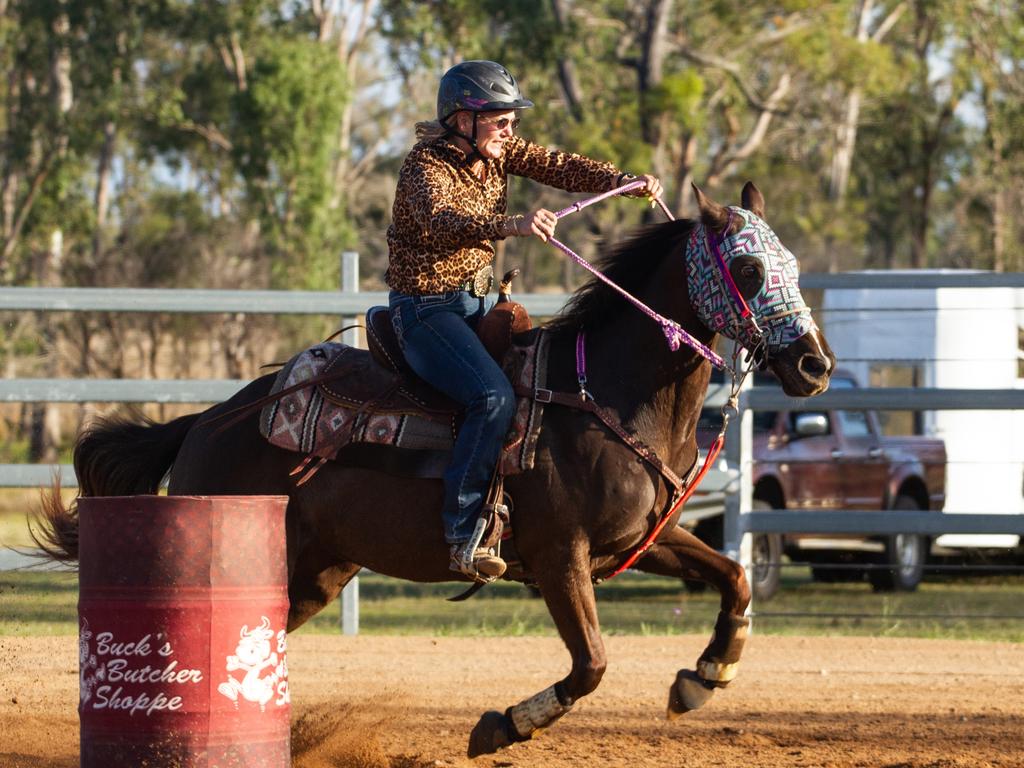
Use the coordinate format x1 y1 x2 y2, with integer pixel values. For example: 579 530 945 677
385 136 620 295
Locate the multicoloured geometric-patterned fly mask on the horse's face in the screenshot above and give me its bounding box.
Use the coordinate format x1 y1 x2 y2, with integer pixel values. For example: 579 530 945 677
686 206 817 362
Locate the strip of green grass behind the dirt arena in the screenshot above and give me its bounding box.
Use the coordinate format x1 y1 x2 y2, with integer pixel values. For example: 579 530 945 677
0 568 1024 642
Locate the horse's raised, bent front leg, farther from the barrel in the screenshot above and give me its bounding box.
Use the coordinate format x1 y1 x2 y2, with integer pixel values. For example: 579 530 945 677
636 527 751 719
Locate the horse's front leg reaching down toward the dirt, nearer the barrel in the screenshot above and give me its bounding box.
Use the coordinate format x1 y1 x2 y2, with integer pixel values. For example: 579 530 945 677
469 547 607 758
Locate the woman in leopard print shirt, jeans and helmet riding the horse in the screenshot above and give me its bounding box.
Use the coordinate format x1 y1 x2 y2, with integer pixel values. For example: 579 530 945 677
385 61 662 582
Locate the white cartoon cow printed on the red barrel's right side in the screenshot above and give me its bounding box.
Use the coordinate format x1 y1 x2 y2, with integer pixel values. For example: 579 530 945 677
217 616 291 712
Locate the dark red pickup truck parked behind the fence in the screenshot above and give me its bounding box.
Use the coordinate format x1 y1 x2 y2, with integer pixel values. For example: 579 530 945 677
694 372 946 599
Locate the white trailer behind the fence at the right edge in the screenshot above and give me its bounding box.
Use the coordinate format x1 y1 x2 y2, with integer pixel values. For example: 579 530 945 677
821 270 1024 549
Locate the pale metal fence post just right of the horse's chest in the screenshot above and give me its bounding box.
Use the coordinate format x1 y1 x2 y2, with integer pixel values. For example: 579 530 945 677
723 376 754 613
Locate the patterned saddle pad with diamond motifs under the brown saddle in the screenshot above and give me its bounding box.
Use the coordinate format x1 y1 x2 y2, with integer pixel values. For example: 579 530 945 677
259 331 548 476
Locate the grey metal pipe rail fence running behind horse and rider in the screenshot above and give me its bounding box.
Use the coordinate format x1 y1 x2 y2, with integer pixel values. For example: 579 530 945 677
0 270 1024 630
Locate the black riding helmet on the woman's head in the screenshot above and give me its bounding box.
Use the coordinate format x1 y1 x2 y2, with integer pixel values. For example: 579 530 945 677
437 60 534 160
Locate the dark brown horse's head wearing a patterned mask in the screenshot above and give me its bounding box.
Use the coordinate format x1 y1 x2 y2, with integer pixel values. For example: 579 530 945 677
686 181 836 397
